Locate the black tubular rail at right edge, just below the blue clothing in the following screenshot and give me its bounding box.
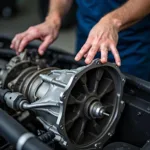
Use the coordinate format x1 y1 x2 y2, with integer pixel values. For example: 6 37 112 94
125 74 150 93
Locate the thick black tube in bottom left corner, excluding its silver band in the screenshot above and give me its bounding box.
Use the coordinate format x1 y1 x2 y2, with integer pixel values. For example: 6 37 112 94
0 109 51 150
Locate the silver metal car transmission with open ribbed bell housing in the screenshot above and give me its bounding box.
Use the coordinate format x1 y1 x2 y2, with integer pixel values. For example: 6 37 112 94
0 51 125 150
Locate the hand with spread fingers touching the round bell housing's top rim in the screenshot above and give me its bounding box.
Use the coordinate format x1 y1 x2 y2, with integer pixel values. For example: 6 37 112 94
75 17 121 66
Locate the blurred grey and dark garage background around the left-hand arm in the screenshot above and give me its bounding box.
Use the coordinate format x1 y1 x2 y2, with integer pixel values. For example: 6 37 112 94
0 0 76 53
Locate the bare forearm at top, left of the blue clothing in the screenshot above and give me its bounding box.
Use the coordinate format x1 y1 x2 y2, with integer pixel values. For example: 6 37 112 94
46 0 73 22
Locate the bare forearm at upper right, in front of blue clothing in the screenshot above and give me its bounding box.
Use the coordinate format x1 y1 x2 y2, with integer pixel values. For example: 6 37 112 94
103 0 150 31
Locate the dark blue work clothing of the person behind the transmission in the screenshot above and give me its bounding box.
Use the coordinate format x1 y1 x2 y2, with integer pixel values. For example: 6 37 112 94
76 0 150 81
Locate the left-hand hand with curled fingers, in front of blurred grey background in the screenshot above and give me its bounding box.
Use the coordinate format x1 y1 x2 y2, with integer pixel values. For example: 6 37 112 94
10 16 60 55
